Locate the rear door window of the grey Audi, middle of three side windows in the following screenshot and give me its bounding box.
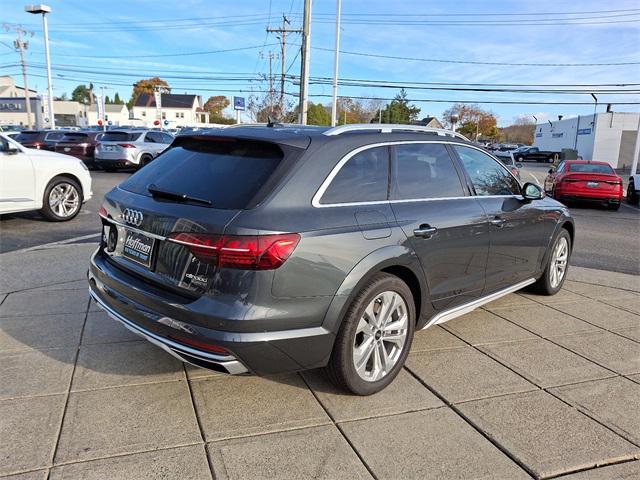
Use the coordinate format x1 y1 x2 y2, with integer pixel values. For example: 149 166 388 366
391 143 465 200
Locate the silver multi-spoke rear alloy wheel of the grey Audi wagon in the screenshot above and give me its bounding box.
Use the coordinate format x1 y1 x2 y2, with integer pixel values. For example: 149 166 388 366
353 291 409 382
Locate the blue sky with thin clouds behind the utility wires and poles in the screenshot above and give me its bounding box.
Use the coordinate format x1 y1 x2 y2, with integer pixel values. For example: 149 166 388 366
0 0 640 126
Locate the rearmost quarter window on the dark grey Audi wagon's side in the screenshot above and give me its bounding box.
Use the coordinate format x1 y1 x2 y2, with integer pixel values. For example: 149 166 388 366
320 147 389 204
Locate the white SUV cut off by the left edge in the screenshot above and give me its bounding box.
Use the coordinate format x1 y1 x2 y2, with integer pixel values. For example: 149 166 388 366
0 134 93 222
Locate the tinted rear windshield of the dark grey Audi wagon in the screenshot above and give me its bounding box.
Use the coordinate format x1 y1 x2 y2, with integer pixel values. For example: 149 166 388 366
120 139 283 209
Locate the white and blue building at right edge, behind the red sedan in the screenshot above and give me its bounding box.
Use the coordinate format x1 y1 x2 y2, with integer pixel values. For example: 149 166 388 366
533 112 640 168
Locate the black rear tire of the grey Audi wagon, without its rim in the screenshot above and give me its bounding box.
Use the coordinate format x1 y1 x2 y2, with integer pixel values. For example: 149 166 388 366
325 273 416 395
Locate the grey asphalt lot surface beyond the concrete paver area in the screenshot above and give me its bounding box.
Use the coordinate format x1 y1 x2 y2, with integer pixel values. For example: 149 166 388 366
0 163 640 275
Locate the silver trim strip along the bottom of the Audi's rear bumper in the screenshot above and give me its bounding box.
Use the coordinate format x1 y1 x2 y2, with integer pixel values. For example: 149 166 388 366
89 288 248 375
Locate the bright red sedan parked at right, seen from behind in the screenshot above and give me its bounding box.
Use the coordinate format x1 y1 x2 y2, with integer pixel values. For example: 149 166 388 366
544 160 622 210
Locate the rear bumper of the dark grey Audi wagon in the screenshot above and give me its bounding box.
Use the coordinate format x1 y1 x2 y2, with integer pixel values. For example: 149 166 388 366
88 252 335 375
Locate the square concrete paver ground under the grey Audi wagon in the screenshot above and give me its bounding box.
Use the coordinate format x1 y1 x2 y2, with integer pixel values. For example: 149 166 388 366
0 244 640 480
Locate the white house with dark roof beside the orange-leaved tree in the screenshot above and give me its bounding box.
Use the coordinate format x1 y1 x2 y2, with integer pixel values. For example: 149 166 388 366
132 93 209 127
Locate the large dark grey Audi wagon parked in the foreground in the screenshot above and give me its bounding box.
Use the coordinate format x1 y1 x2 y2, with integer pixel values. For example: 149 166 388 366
88 125 574 395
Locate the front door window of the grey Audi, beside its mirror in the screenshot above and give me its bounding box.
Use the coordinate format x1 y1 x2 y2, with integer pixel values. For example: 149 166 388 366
453 145 520 196
